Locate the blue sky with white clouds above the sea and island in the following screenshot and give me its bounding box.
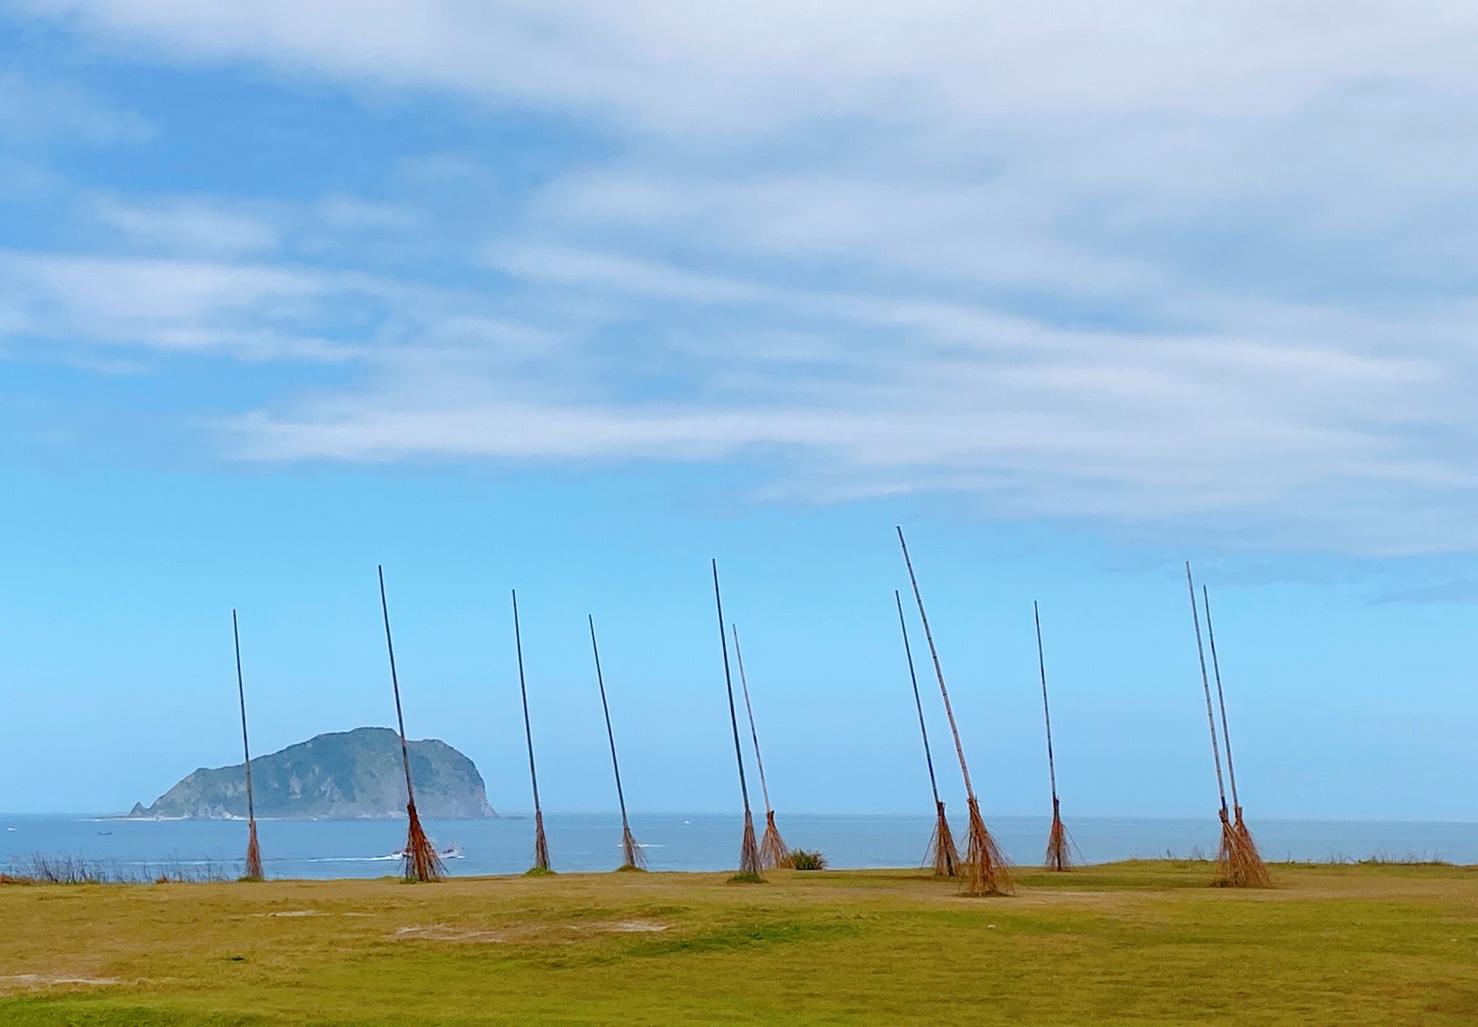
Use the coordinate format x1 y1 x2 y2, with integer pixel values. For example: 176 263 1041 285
0 0 1478 820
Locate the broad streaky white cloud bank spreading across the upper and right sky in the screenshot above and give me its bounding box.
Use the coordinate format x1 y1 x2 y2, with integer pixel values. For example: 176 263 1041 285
22 0 1478 553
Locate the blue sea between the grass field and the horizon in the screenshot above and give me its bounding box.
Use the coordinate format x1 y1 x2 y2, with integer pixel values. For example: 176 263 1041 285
0 811 1478 878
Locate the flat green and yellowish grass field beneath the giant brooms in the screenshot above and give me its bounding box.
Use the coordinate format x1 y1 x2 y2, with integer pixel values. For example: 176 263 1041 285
0 861 1478 1024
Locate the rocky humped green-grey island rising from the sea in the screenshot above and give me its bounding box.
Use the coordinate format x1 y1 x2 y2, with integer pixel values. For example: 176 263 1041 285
129 727 497 820
